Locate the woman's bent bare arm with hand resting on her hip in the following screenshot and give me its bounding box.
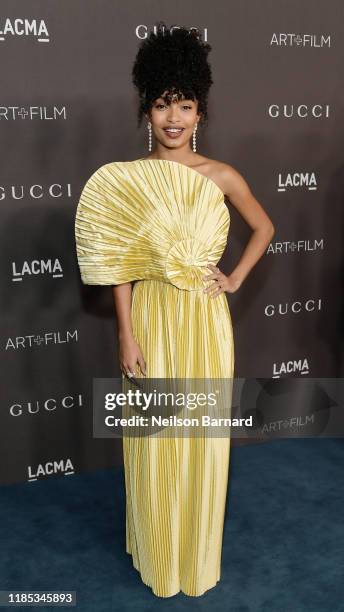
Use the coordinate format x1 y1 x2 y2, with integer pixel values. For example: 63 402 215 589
203 164 275 297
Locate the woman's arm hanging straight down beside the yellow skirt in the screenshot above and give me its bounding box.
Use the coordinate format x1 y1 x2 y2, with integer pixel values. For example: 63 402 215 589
112 282 146 376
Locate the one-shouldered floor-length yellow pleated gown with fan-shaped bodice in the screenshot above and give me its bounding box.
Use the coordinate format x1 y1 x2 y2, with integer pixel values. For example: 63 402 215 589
75 159 234 597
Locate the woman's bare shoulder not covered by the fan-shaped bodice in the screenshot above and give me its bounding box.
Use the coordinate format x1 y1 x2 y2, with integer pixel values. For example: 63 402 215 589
193 156 249 197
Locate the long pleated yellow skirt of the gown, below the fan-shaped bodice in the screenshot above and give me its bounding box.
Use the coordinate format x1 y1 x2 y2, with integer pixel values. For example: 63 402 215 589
123 280 234 597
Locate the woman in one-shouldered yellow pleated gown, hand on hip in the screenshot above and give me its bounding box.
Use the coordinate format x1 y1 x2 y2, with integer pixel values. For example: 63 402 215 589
76 22 274 597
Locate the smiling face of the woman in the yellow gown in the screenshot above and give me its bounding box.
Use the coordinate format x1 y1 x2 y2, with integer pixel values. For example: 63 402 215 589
147 92 200 148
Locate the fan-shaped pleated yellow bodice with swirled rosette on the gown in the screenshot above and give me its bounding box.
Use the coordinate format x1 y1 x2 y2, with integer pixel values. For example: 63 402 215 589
75 159 230 291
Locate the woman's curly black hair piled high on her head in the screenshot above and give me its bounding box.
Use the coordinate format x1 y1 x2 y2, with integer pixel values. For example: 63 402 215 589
132 21 213 126
